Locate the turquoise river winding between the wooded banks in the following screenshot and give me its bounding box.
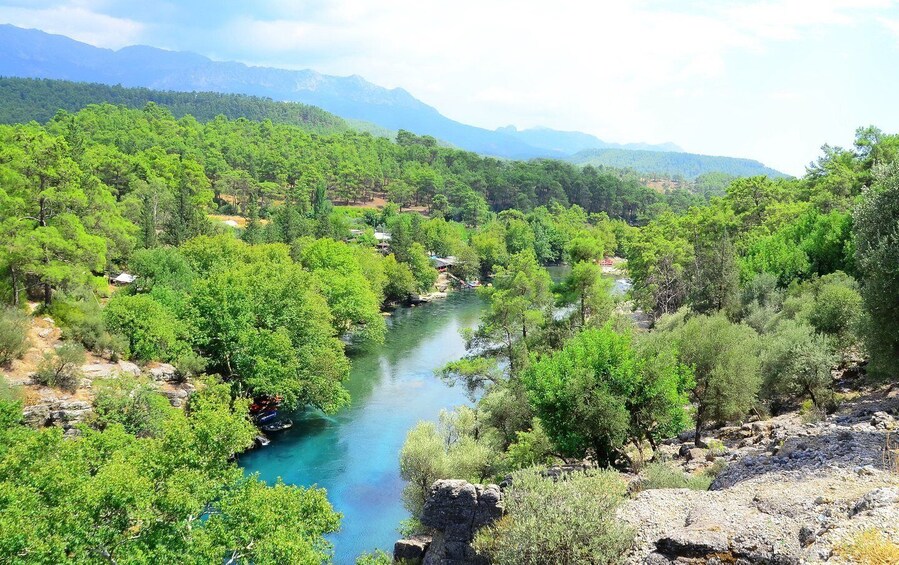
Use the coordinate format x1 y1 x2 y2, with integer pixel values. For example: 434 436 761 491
240 292 483 564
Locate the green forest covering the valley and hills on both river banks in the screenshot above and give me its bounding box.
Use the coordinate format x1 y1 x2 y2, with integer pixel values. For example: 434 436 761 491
0 92 899 563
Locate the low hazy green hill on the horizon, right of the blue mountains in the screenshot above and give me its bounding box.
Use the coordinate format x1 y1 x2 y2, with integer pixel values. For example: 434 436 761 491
566 149 788 179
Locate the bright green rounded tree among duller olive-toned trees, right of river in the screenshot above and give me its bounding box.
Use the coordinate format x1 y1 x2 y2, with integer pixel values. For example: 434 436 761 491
522 326 689 465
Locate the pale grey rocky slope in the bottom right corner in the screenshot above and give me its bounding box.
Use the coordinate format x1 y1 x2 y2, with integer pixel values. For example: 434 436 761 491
619 391 899 565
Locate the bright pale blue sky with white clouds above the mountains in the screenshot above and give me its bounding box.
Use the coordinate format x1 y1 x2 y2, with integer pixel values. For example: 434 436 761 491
0 0 899 175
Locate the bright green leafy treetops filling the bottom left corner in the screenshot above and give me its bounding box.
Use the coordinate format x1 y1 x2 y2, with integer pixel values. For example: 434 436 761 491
0 376 339 564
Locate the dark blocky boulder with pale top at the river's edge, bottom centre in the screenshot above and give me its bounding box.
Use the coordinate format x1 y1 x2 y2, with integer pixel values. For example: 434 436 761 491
394 479 503 565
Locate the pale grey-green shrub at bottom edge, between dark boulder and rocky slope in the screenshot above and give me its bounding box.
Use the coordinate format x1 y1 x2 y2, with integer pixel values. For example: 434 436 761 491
474 470 633 565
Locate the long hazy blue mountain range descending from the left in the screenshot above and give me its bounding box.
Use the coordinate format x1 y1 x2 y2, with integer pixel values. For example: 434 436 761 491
0 25 788 174
